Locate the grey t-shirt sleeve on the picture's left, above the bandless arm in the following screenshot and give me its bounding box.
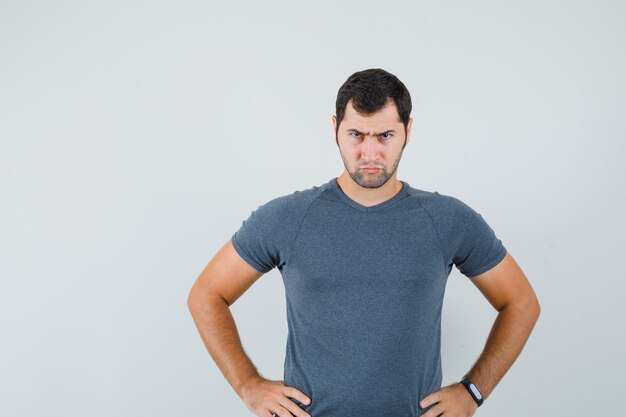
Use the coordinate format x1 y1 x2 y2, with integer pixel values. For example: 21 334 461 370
231 198 293 273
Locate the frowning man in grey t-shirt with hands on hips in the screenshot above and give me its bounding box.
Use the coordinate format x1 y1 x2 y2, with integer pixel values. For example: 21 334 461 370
188 69 539 417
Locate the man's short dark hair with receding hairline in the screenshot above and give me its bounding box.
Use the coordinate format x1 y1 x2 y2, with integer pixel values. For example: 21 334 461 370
335 68 411 140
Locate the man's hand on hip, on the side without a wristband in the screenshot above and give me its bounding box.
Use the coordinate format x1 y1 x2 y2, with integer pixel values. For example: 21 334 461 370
241 377 311 417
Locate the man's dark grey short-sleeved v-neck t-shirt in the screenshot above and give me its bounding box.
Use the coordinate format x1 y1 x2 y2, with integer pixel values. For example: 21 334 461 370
232 178 506 417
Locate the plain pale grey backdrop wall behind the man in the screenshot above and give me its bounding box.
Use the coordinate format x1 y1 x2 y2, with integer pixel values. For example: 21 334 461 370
0 0 626 417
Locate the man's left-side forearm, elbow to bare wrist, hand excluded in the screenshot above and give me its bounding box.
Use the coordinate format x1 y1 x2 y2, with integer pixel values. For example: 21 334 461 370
187 296 260 397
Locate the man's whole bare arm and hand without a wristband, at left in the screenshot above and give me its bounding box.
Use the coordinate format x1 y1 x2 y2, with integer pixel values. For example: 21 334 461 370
187 240 309 417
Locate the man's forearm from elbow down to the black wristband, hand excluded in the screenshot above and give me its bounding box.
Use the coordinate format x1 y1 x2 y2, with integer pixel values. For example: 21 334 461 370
460 295 540 398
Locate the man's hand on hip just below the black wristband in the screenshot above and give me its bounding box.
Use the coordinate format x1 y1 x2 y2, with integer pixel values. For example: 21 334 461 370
420 383 478 417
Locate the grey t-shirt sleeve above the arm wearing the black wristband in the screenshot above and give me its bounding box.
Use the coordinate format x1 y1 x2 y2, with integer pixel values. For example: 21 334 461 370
452 200 506 278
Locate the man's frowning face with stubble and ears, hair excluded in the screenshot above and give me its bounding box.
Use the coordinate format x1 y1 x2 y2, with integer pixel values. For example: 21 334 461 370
332 100 413 188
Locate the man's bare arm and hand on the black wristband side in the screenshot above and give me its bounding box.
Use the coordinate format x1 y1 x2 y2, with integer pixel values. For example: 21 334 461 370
420 253 540 417
